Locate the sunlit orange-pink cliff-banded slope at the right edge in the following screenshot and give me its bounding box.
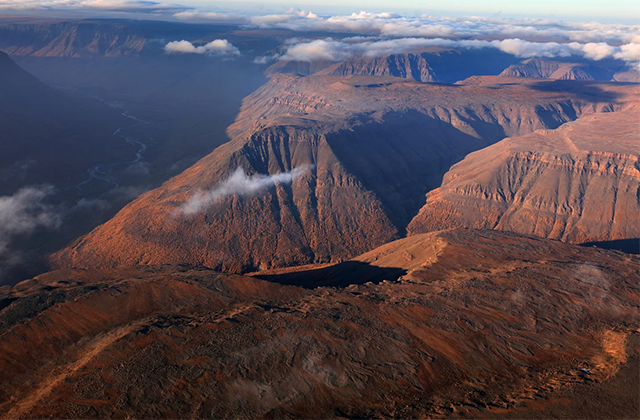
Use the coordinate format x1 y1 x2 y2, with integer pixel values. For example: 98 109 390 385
408 106 640 243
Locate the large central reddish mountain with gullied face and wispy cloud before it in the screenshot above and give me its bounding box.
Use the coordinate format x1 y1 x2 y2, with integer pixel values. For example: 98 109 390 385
52 76 631 272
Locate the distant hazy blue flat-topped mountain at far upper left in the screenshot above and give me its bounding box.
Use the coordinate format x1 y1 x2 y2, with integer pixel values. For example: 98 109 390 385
0 16 281 58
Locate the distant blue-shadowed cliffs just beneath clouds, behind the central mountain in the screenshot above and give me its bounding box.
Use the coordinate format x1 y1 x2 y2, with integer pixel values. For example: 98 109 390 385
266 47 516 83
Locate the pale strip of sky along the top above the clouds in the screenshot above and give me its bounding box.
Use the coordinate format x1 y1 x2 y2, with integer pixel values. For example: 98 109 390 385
0 0 640 24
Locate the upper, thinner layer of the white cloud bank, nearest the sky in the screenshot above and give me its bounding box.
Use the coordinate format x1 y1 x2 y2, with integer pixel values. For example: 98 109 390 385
174 9 640 44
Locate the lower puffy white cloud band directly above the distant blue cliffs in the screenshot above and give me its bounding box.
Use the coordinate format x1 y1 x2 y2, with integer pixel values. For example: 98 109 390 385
280 38 640 65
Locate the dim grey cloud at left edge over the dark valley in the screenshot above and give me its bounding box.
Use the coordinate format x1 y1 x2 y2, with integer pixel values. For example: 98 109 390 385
0 186 62 255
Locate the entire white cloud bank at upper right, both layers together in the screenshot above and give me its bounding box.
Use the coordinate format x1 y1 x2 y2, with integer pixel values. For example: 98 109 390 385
169 9 640 66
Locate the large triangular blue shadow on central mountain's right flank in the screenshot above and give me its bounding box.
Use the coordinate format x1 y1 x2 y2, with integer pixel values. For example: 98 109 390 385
327 110 506 235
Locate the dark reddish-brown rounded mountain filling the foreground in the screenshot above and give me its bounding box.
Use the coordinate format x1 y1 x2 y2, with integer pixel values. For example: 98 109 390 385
0 230 640 419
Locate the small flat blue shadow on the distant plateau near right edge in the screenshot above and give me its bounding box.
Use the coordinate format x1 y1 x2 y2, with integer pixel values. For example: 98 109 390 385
528 80 637 103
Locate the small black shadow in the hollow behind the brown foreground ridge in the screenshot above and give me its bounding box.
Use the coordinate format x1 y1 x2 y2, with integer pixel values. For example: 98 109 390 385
255 261 407 289
